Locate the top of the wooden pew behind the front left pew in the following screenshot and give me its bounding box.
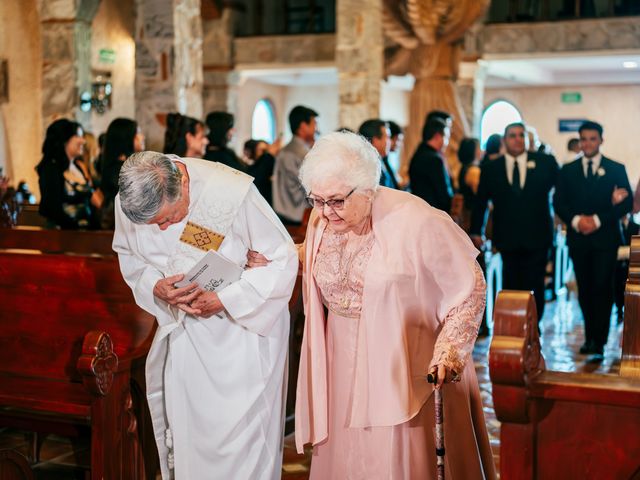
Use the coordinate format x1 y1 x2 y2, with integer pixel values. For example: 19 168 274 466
0 226 115 255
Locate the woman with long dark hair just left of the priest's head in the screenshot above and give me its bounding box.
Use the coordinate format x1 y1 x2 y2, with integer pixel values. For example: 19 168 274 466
100 118 145 230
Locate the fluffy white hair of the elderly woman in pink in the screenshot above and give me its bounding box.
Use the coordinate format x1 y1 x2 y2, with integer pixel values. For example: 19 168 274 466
300 131 382 194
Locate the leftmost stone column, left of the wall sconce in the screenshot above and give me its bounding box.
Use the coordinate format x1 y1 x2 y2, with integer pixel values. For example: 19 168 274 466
38 0 100 130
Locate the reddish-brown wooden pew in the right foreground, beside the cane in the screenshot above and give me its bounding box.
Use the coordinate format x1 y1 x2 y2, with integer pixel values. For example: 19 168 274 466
489 237 640 480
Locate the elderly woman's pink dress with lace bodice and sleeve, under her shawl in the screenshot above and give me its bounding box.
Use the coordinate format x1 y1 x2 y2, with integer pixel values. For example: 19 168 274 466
310 229 484 480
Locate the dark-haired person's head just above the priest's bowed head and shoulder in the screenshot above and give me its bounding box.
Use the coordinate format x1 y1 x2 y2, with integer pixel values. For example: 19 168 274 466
163 113 209 158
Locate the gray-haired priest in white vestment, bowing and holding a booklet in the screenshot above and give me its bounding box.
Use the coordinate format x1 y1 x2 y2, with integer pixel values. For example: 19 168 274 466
113 152 298 480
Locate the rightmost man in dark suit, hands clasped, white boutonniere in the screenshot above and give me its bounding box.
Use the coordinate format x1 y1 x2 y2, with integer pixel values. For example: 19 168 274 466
554 122 633 361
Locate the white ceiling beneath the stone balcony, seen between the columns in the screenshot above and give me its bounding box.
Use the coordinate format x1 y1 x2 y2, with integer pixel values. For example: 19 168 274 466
239 52 640 90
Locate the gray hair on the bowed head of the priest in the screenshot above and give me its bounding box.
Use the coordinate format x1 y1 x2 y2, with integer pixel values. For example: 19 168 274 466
118 152 182 223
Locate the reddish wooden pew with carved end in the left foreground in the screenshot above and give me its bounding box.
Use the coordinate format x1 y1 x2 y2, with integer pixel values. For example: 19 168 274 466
0 246 158 479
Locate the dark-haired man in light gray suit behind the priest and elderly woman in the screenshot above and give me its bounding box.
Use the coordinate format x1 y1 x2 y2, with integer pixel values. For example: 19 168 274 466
272 105 318 225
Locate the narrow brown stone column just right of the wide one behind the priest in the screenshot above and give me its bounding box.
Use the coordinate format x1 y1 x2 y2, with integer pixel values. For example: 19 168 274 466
202 8 236 115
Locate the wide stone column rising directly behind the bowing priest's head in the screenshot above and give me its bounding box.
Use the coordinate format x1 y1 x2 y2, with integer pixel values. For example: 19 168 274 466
135 0 202 151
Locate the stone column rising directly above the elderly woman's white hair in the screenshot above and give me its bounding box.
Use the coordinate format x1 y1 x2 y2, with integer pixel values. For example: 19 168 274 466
336 0 384 130
